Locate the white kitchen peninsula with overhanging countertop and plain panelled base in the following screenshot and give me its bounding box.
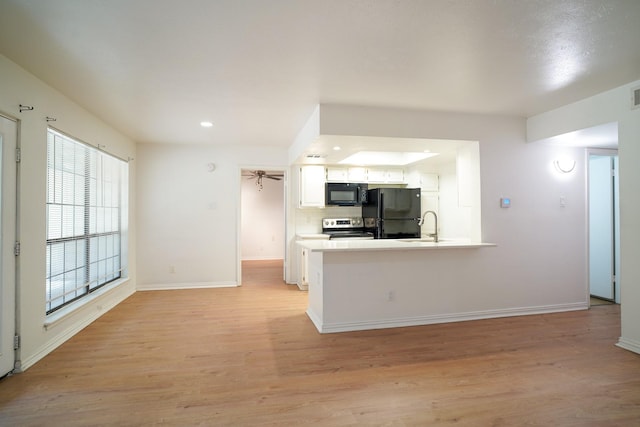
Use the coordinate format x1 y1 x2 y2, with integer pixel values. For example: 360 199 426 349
298 239 500 333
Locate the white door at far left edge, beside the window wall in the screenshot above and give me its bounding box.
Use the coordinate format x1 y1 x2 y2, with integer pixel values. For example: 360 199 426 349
0 116 18 376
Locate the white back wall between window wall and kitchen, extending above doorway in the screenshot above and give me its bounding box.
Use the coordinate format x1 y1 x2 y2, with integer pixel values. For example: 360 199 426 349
136 144 287 289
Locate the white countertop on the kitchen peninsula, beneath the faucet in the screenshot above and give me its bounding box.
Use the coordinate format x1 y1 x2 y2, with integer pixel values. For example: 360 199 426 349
298 239 496 252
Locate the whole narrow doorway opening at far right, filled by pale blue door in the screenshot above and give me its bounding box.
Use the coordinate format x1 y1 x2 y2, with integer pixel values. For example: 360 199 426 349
587 150 620 305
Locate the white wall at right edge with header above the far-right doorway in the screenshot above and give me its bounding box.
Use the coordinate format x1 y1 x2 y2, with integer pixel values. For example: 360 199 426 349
528 81 640 353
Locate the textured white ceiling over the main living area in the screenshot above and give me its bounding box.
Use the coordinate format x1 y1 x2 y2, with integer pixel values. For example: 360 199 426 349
0 0 640 147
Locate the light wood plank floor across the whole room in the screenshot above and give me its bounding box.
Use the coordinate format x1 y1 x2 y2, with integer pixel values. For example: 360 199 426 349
0 262 640 426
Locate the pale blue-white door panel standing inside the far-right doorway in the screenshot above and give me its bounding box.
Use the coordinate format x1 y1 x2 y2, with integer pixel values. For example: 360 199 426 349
589 154 616 301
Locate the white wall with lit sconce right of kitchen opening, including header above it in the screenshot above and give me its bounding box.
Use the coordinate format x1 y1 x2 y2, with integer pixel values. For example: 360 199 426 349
292 105 588 311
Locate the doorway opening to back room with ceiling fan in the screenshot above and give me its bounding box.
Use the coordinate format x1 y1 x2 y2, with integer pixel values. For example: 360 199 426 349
239 167 287 283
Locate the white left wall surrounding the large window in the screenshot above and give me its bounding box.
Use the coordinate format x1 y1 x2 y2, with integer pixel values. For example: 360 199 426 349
0 55 136 369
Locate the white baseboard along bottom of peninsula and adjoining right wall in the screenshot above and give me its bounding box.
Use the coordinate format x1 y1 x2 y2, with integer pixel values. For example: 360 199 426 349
307 302 589 334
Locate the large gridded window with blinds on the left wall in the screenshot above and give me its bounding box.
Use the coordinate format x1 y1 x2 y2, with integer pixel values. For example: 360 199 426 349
46 128 127 314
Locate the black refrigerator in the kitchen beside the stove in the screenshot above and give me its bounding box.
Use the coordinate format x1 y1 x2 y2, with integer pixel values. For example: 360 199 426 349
362 188 420 239
